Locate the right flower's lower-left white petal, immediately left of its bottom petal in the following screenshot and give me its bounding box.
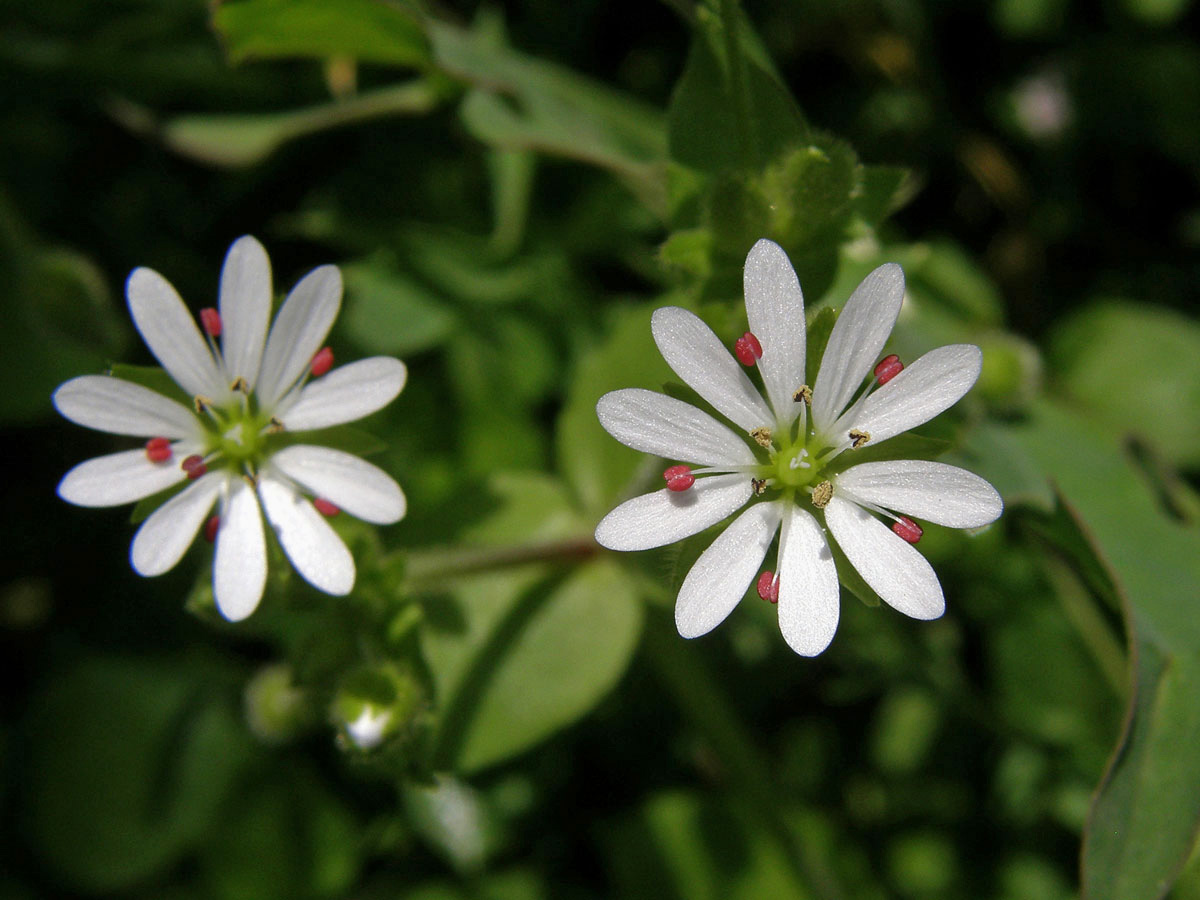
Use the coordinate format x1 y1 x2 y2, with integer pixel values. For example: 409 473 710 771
676 503 780 637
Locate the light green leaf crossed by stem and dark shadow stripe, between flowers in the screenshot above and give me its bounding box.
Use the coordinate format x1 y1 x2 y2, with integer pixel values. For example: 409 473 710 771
422 474 642 772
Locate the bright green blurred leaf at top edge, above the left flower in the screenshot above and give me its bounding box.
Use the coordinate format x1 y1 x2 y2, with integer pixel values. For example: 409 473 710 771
212 0 430 66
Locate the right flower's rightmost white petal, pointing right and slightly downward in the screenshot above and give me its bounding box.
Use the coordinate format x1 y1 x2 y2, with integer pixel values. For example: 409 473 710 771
834 460 1004 528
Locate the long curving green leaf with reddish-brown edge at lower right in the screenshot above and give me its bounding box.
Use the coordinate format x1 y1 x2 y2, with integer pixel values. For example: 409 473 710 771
1014 406 1200 900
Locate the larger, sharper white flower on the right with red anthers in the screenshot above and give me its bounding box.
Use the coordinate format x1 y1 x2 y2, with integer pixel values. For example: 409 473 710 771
596 240 1003 656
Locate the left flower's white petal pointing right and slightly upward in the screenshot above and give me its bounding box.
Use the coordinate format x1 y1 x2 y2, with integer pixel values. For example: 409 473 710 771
276 356 408 431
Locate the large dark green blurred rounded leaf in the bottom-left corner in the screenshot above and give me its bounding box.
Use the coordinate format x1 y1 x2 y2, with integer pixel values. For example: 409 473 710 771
25 658 248 893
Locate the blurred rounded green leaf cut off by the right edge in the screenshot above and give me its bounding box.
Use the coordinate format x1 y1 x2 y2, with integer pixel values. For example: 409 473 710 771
1049 300 1200 467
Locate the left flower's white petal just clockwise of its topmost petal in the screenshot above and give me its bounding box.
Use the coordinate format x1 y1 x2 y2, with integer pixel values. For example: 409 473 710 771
254 265 344 405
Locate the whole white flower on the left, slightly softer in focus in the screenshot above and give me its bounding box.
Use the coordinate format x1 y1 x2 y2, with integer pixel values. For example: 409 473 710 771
54 236 407 622
